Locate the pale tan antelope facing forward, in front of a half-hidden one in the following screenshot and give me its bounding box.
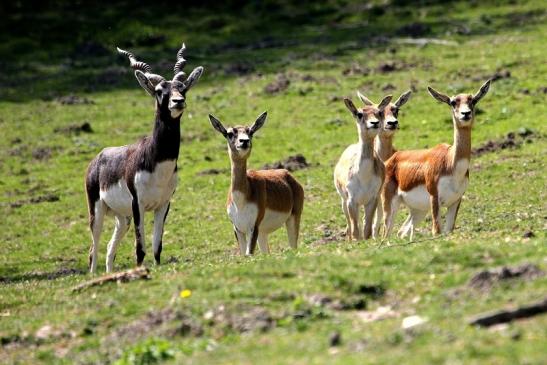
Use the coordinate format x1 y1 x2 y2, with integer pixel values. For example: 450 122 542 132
334 95 391 240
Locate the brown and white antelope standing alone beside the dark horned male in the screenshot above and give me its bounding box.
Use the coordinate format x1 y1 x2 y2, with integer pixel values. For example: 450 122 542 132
209 112 304 255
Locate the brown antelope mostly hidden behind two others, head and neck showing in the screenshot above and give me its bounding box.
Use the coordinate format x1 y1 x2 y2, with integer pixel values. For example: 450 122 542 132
357 90 412 238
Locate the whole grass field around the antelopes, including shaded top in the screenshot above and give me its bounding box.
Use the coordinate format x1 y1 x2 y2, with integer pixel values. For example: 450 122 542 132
0 0 547 364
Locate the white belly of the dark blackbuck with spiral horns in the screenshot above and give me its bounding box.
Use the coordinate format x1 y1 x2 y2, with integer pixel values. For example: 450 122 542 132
135 160 177 211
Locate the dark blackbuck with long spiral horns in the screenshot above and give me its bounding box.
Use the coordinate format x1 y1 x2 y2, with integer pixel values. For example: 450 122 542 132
85 44 203 273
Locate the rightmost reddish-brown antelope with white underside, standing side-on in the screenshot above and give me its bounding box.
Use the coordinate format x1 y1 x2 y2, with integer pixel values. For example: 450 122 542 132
382 80 491 240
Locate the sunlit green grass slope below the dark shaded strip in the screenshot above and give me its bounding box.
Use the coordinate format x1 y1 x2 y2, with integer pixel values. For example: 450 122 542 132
0 1 547 364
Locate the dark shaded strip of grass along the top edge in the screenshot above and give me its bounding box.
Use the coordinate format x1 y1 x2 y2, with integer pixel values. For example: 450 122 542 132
0 0 546 102
